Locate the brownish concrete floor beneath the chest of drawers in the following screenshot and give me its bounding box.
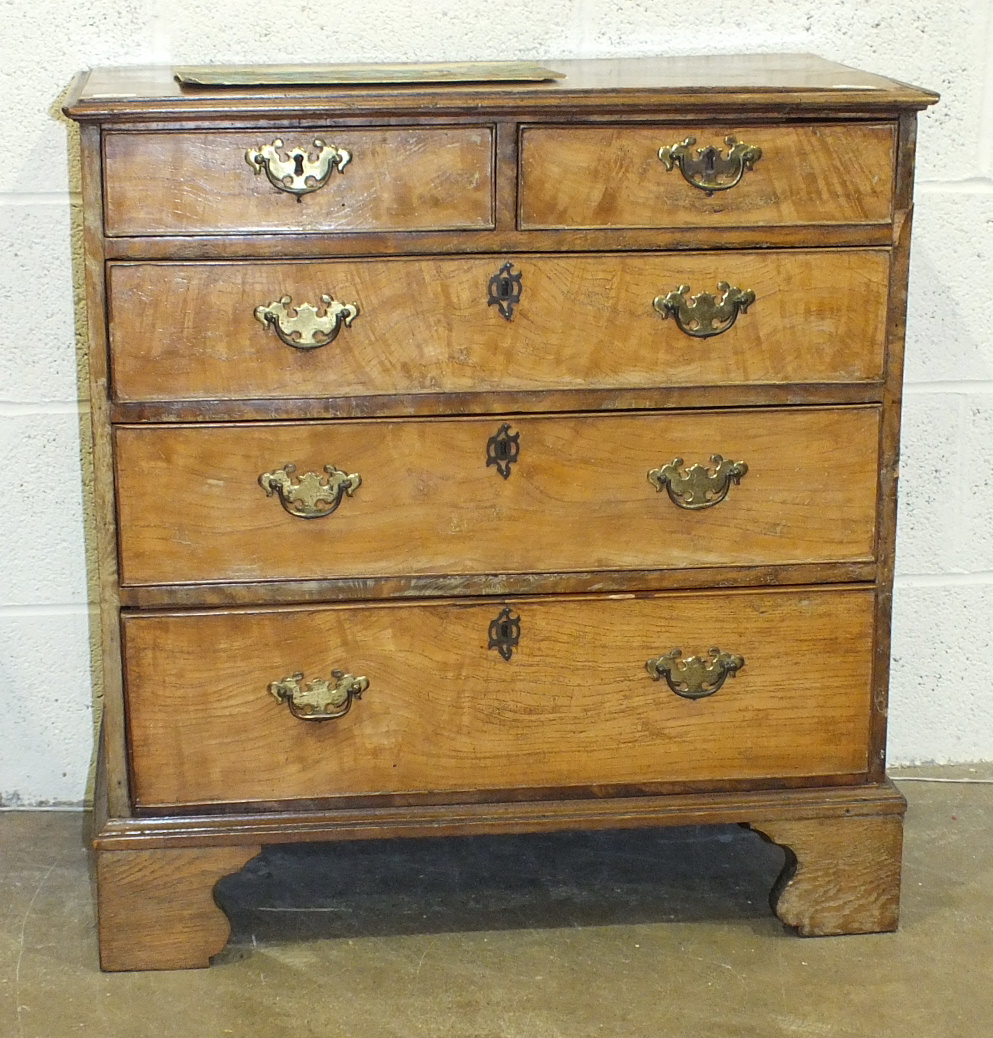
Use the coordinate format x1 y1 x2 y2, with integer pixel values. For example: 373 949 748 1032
0 765 993 1038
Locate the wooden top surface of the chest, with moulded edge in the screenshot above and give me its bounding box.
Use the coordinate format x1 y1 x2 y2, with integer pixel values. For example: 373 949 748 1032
65 54 937 120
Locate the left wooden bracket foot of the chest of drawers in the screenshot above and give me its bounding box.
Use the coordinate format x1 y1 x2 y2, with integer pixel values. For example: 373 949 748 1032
96 845 261 972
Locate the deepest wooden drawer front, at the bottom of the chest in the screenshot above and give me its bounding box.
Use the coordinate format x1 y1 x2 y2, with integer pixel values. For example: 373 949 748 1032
122 590 874 807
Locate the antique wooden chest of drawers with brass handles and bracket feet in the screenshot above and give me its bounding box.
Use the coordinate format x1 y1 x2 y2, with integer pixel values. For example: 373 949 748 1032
66 56 936 969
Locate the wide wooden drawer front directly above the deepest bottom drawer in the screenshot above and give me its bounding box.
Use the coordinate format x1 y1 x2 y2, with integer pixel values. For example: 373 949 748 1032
116 407 879 584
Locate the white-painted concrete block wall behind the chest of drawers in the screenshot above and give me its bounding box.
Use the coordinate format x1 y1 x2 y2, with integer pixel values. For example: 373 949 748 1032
0 0 993 804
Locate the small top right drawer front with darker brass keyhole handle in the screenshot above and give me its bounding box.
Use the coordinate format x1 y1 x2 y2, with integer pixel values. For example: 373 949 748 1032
520 124 895 228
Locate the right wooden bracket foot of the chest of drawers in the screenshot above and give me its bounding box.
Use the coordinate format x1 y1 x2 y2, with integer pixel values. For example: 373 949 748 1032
750 815 904 937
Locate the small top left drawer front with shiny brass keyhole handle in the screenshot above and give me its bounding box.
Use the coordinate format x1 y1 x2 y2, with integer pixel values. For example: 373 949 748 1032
104 127 493 236
